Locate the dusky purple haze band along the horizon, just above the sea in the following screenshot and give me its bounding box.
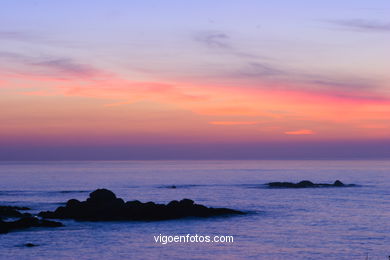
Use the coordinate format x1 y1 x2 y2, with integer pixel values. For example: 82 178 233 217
0 140 390 161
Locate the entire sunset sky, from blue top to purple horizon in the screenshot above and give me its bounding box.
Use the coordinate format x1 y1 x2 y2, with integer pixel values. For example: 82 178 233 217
0 0 390 160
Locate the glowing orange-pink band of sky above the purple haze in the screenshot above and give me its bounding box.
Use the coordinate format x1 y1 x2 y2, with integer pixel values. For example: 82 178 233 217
0 69 390 146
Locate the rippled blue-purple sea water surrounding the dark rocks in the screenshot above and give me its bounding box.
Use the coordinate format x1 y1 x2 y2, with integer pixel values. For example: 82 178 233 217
0 161 390 260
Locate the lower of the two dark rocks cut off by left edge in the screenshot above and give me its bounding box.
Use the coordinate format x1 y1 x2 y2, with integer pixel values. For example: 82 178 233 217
0 216 63 234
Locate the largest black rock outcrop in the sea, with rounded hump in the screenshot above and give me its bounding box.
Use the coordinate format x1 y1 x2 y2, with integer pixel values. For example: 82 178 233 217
39 189 244 221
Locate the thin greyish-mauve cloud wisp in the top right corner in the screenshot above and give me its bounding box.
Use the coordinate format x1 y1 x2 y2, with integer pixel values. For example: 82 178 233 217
330 19 390 32
